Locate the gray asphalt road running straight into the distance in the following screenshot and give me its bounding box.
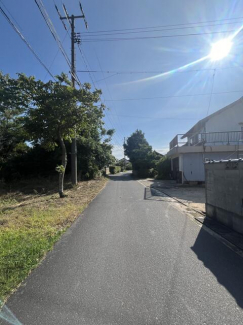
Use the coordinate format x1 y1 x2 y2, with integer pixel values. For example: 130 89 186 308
0 174 243 325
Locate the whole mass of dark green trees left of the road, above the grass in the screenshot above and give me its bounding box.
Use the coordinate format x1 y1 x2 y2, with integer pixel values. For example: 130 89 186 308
0 73 114 197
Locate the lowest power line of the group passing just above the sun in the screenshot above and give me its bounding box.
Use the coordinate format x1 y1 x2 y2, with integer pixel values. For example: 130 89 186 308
82 30 235 43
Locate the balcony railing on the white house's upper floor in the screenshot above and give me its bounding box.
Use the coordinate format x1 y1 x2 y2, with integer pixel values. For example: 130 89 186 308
170 131 243 149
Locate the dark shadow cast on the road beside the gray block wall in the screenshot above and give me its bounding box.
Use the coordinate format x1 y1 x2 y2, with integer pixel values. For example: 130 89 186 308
191 221 243 308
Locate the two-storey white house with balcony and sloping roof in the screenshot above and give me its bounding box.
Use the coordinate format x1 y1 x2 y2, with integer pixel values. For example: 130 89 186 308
167 97 243 183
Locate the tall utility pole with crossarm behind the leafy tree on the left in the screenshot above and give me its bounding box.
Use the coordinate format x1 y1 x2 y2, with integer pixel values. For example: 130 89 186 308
55 2 88 185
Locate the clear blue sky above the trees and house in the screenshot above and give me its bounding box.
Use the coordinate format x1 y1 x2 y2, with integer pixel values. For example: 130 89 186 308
0 0 243 158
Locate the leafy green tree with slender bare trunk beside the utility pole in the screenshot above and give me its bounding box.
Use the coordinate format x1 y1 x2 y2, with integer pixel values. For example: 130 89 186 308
22 74 105 197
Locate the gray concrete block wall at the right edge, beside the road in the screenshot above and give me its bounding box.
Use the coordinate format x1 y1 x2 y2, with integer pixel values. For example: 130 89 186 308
205 160 243 233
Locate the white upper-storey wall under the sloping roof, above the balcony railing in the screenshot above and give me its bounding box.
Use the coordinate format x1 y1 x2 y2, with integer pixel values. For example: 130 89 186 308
205 99 243 133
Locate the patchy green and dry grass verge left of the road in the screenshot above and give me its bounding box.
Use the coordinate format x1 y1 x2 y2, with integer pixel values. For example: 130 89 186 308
0 178 107 301
